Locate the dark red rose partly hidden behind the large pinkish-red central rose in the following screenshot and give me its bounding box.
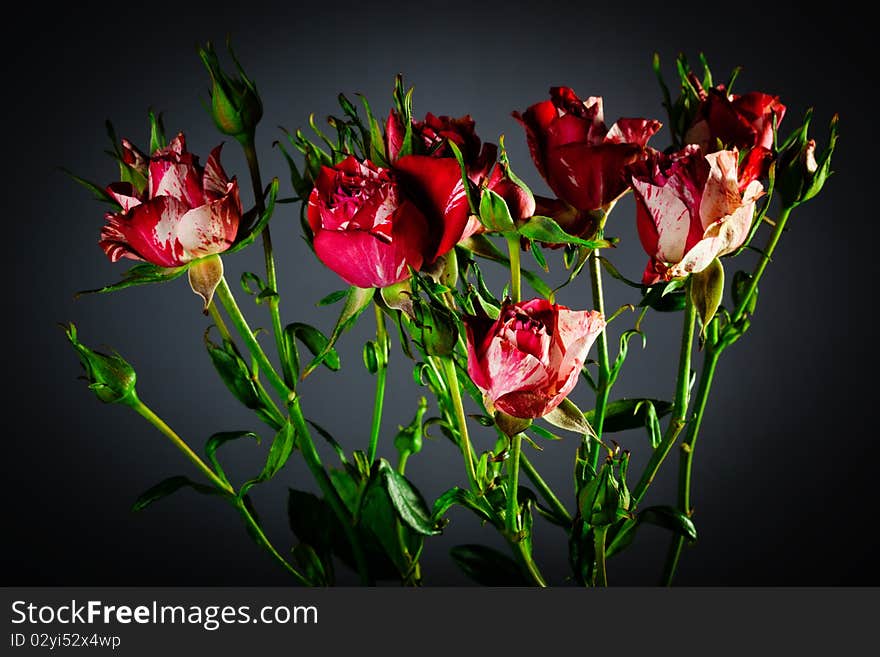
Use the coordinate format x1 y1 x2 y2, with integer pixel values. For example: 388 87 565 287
385 110 498 184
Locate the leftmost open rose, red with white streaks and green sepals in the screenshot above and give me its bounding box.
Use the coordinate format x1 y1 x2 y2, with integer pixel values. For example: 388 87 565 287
99 133 242 267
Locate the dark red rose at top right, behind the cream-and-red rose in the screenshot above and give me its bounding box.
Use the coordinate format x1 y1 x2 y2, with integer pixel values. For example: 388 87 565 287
684 86 785 153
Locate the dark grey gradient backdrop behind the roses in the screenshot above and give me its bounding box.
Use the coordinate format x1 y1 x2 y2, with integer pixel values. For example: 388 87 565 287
0 2 880 585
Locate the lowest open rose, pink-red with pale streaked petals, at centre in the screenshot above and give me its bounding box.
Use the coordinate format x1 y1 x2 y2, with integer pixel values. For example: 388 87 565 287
465 299 605 418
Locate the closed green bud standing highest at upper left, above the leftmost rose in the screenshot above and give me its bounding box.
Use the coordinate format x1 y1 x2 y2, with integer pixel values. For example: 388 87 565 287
199 42 263 140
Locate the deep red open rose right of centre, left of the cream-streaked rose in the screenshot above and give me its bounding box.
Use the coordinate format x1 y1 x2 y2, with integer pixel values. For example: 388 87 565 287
513 87 661 218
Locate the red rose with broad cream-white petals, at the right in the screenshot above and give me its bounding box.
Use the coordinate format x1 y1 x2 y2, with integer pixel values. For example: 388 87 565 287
631 145 764 284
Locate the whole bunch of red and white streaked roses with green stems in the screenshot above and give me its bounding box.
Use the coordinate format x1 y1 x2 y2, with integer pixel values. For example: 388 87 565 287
66 44 837 586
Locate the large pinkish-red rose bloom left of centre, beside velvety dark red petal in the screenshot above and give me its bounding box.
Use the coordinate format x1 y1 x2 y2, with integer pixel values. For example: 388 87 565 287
308 156 432 288
